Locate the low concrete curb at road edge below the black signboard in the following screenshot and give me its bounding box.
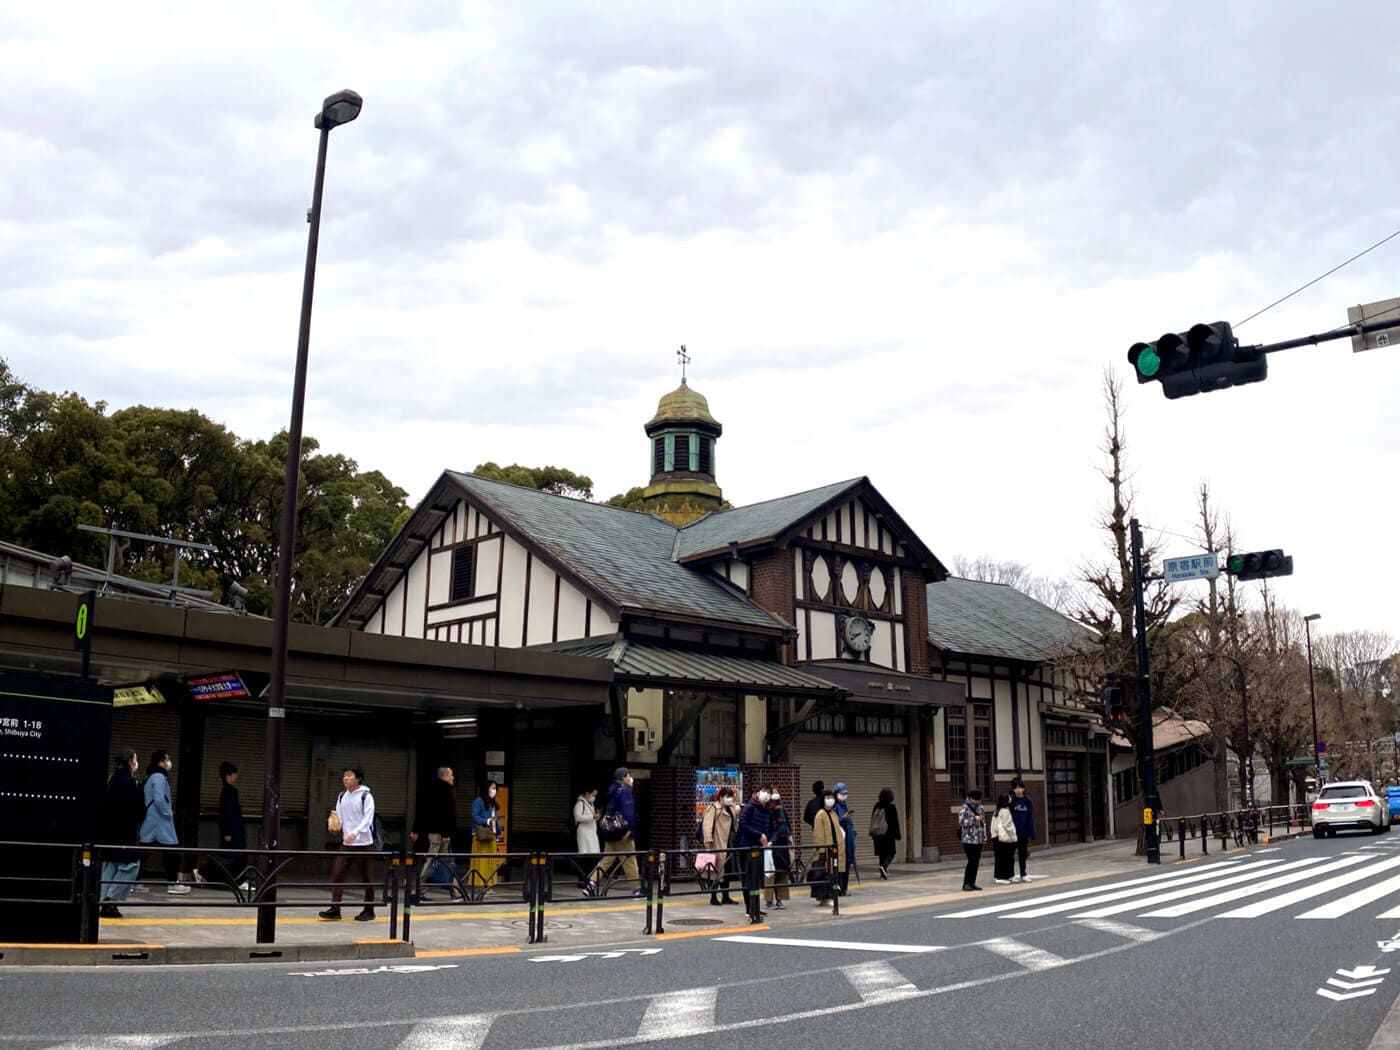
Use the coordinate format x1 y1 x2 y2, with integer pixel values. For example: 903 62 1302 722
0 939 413 969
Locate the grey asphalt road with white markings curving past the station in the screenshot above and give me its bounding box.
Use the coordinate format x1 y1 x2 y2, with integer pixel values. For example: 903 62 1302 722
0 834 1400 1050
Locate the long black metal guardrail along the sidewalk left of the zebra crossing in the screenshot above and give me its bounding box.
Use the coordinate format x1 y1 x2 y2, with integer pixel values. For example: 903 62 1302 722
0 841 844 945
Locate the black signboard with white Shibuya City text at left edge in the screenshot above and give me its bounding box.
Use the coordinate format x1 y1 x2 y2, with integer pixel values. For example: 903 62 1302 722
0 672 112 944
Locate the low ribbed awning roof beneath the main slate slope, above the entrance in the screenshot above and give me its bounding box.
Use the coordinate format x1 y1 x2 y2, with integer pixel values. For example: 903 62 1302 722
532 634 846 696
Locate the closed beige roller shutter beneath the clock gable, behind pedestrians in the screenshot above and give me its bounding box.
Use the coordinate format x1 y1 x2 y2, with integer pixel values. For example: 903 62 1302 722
788 734 909 879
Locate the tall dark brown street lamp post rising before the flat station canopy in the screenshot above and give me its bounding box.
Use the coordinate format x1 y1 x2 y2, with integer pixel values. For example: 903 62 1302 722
258 91 364 944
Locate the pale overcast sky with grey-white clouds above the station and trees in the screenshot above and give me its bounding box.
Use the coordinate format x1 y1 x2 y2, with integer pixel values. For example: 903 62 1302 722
0 0 1400 634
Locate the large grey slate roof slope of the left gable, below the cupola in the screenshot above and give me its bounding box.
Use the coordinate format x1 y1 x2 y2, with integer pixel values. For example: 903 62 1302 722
447 470 790 630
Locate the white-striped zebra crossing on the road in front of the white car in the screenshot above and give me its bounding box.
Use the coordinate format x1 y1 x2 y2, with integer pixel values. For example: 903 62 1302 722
938 843 1400 937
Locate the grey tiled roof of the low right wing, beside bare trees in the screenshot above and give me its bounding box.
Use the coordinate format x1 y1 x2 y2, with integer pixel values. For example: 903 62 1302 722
928 577 1091 664
